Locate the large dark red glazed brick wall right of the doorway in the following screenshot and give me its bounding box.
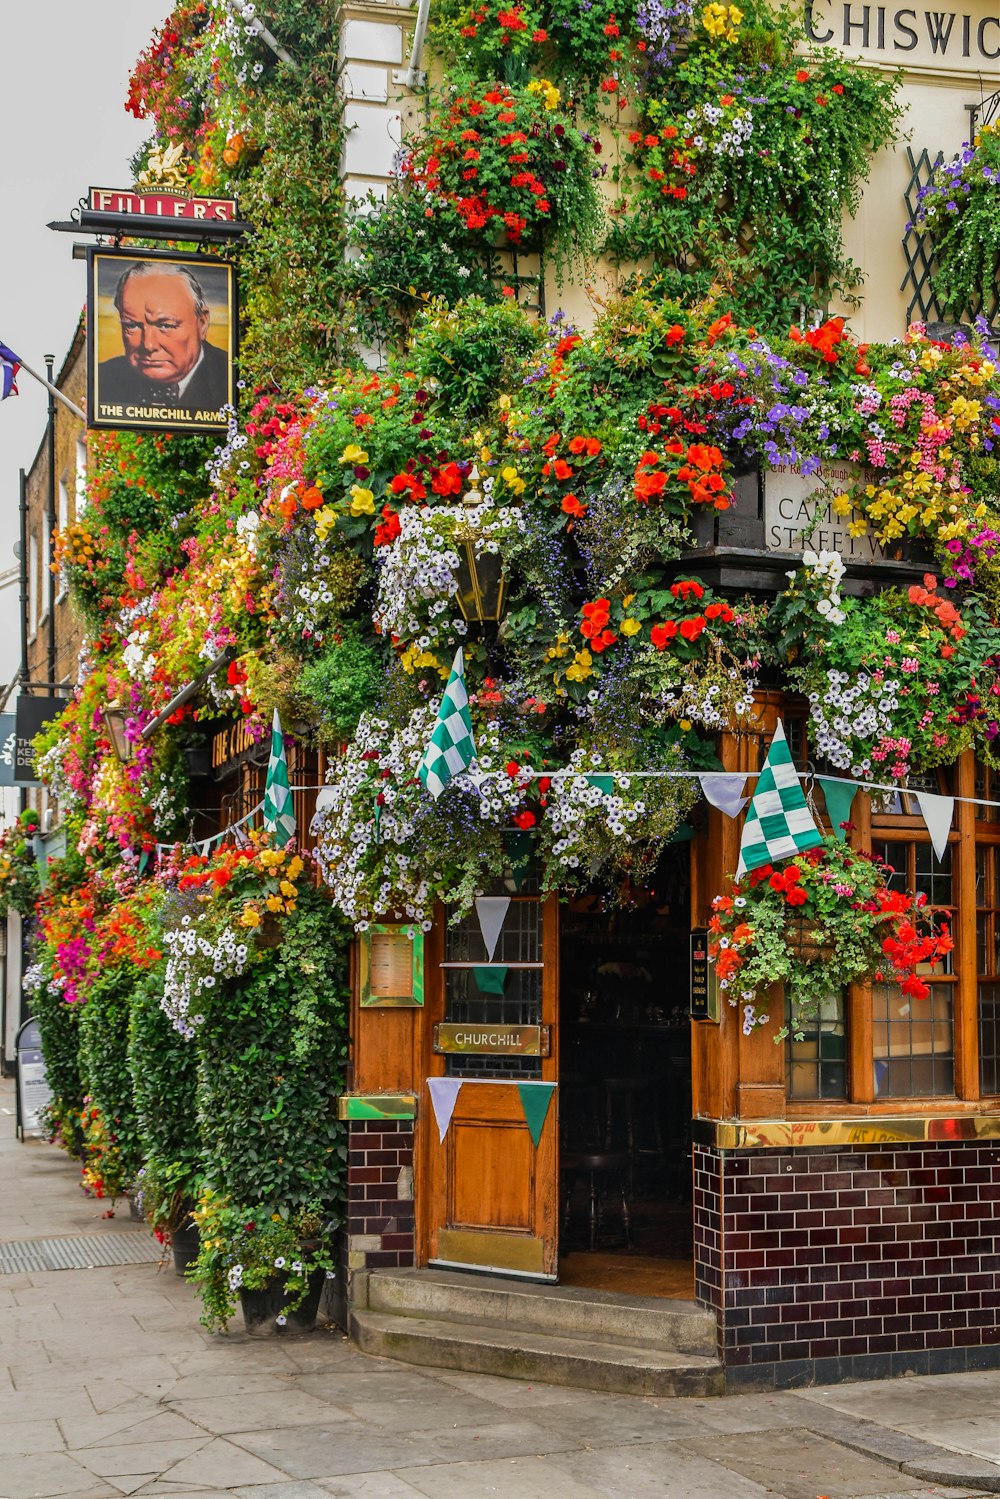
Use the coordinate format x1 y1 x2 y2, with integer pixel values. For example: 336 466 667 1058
694 1141 1000 1387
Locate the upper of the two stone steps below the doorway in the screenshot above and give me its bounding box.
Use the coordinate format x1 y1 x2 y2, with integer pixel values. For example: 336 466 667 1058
364 1270 717 1360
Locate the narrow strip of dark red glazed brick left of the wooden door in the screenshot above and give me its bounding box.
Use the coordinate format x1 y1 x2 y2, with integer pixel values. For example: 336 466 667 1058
348 1120 414 1271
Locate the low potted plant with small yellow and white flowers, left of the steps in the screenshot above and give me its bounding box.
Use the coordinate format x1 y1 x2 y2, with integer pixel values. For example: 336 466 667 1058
189 1189 336 1337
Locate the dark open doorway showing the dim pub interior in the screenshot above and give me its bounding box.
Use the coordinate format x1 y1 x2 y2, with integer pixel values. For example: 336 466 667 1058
559 844 694 1298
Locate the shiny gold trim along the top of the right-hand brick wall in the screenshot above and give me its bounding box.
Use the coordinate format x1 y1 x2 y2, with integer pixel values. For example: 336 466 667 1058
694 1114 1000 1150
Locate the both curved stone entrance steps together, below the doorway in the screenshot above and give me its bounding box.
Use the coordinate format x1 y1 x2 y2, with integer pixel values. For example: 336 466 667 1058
351 1270 724 1396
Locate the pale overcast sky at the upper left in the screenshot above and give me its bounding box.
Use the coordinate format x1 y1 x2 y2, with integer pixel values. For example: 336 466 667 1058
0 0 169 571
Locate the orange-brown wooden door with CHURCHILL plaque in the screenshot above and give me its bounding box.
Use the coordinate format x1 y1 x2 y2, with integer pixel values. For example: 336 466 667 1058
420 896 559 1280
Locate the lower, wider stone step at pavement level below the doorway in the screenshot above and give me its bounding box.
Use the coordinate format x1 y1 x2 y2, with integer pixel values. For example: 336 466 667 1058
351 1310 726 1397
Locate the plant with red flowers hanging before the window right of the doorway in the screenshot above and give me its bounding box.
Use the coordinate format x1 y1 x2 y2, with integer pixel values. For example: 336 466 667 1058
708 836 954 1040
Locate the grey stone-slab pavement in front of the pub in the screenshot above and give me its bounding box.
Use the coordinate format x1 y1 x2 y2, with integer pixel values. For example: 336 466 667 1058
0 1082 1000 1499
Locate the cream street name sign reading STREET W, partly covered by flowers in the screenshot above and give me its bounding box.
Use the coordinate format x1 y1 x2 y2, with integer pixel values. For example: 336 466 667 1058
763 463 892 564
